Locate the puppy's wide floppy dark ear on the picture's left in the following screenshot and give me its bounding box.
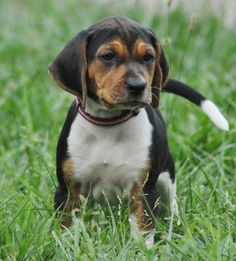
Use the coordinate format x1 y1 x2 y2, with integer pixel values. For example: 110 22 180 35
48 30 89 106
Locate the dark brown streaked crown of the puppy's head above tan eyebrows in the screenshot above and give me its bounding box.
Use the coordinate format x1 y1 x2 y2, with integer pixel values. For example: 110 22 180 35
88 17 151 50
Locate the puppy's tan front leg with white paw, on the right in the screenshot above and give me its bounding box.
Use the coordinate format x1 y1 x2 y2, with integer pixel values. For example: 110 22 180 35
129 183 154 248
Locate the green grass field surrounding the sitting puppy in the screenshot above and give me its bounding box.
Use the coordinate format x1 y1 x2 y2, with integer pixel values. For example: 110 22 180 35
0 0 236 261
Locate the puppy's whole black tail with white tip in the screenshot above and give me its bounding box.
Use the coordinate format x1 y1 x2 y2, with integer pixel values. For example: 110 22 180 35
163 79 229 131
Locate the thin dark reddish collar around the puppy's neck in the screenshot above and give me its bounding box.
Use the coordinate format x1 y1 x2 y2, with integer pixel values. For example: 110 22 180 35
76 97 140 126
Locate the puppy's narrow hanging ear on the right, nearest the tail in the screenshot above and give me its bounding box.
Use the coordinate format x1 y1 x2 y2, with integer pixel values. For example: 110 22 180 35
152 42 169 108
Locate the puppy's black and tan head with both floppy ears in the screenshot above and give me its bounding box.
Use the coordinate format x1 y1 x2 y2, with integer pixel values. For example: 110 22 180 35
49 17 168 109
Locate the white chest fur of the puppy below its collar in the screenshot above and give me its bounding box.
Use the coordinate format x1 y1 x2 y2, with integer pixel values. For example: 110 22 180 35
68 109 152 201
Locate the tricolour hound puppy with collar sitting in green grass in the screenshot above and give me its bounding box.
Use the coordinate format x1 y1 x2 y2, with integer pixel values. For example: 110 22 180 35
49 17 227 246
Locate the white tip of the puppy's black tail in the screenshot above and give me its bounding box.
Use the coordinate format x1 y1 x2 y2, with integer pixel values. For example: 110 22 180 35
201 100 229 131
